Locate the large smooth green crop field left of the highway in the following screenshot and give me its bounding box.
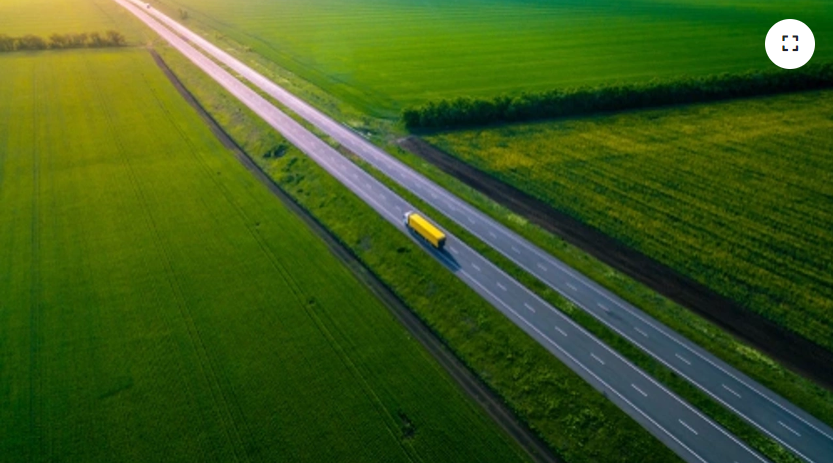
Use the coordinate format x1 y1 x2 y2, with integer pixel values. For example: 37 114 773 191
0 49 521 462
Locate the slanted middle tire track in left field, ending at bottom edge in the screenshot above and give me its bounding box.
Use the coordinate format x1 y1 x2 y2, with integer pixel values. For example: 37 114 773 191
87 56 248 461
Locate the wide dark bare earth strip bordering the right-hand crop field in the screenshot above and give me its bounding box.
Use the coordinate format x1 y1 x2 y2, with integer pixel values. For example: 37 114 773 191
398 136 833 390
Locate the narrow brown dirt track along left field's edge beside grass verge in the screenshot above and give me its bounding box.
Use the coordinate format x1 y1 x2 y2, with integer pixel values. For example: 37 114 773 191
150 50 564 463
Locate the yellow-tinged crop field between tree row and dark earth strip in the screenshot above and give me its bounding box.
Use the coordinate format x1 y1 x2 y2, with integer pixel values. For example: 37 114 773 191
428 91 833 349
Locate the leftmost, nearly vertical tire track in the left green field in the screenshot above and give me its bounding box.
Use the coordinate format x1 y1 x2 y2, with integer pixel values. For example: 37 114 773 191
29 55 43 461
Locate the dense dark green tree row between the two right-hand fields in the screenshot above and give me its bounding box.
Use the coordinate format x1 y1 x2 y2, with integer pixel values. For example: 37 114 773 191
402 62 833 129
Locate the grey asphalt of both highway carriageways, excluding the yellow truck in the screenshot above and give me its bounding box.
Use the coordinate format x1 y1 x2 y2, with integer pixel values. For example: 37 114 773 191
115 0 833 463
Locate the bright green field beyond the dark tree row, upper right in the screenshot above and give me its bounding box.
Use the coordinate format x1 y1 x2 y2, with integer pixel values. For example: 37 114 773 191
158 0 833 116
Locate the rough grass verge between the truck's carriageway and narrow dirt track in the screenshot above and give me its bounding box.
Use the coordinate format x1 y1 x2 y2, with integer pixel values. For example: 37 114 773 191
153 44 679 463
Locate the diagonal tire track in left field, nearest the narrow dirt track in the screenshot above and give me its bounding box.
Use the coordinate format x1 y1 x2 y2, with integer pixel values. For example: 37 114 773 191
143 55 422 462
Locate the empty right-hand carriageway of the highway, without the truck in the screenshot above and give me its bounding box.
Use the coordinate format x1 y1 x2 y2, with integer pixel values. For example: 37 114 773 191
123 2 833 463
